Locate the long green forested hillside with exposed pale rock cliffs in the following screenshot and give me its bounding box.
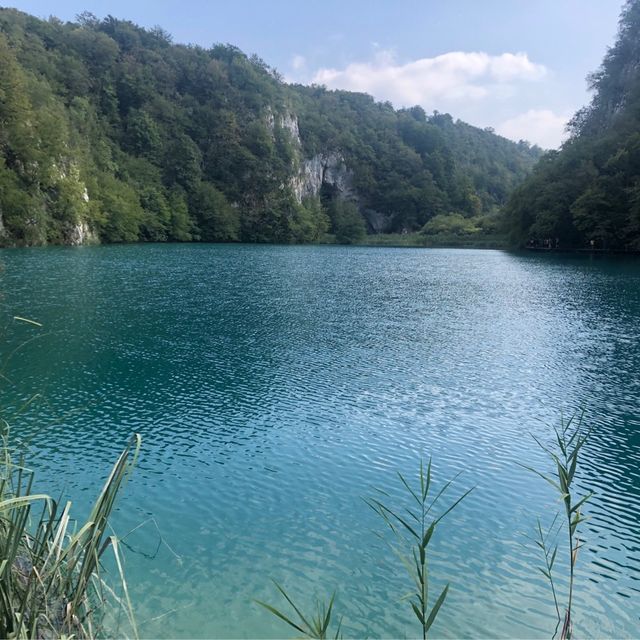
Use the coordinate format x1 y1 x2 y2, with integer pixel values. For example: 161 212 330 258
0 9 541 245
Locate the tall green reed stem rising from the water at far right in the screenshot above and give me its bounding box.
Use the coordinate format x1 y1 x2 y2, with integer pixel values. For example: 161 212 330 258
522 413 593 640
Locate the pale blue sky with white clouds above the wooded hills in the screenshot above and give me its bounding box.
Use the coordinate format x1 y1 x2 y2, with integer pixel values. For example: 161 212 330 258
6 0 622 148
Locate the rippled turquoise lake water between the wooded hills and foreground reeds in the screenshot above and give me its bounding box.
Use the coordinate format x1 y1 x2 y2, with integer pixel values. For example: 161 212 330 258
0 245 640 637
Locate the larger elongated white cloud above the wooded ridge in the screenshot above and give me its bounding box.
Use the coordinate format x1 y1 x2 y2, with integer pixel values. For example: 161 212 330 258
312 50 547 110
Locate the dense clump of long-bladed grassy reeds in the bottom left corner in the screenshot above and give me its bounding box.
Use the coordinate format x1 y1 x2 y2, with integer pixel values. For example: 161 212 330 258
0 424 140 638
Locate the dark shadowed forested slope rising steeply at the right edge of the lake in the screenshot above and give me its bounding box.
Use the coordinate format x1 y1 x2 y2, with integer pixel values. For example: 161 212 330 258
505 0 640 250
